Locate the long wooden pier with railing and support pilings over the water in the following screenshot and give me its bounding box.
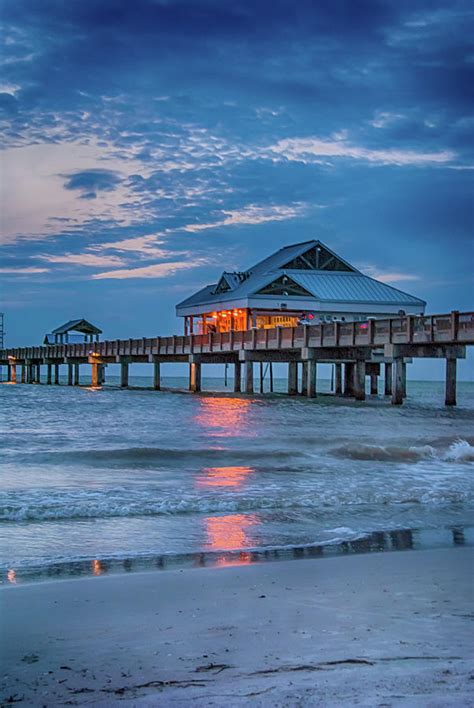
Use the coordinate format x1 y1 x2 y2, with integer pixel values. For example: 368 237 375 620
0 311 474 406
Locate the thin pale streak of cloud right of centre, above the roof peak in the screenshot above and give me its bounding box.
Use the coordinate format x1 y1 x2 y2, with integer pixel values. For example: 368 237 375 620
268 137 456 166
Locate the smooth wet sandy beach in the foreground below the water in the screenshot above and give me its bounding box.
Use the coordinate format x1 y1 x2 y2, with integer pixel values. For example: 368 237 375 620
0 548 474 707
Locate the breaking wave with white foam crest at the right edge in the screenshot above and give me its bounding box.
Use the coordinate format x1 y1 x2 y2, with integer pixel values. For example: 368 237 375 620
333 440 474 462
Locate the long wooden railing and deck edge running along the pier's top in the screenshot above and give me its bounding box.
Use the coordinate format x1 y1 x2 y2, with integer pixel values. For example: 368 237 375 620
0 312 474 363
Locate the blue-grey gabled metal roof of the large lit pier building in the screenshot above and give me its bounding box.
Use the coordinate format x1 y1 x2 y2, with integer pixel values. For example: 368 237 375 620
176 240 426 317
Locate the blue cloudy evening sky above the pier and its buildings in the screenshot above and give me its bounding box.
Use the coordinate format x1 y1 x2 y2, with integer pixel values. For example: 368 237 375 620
0 0 474 378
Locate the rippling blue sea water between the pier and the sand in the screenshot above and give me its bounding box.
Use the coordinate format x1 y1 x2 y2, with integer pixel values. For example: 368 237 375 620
0 377 474 582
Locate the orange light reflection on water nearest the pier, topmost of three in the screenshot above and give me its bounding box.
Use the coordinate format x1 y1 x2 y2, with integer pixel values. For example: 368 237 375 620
194 398 251 438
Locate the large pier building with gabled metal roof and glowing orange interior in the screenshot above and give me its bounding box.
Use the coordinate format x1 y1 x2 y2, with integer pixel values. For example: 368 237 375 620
176 240 426 335
